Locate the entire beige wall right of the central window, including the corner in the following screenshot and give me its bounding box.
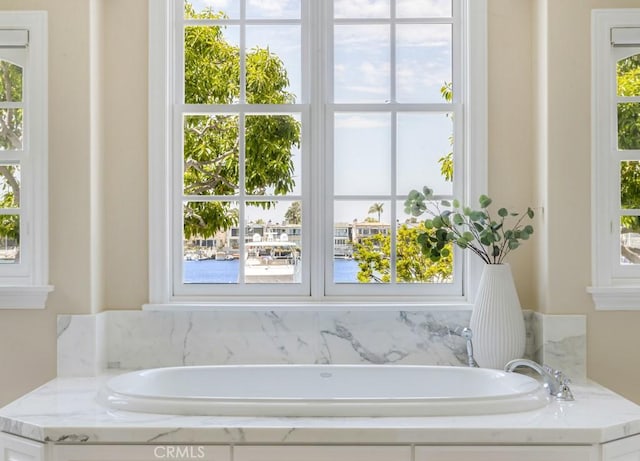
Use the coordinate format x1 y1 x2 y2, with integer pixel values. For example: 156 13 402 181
488 0 640 403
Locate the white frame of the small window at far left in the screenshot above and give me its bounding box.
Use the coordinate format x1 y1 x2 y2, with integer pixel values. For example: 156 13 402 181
0 11 53 309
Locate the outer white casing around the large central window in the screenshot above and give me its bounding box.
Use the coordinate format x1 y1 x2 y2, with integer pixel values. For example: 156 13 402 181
145 0 487 309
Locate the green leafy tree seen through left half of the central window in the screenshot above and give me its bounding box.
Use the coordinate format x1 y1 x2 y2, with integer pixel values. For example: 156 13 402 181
184 2 301 239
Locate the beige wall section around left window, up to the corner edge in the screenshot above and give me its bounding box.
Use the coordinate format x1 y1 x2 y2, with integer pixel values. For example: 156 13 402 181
0 0 95 404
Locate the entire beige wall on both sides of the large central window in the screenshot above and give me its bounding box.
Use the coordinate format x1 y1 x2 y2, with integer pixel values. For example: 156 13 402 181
0 0 640 405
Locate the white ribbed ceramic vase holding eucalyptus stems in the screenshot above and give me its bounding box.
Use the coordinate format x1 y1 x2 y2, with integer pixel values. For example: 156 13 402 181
469 264 526 369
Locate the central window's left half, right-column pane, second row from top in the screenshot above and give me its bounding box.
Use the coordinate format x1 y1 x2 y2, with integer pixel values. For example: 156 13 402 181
247 25 302 104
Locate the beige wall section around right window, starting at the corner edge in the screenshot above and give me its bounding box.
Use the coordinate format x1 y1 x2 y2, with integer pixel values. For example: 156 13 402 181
536 0 640 403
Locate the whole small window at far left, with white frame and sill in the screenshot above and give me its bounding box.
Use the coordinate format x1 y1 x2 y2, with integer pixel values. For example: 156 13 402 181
0 12 52 308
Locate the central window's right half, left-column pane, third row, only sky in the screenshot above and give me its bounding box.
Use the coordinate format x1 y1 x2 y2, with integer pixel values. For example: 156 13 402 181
334 113 391 195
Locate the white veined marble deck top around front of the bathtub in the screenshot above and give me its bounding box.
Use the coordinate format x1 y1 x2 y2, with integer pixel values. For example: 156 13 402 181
0 375 640 444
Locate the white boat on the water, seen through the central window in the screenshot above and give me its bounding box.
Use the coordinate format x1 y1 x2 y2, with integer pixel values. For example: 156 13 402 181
244 234 300 283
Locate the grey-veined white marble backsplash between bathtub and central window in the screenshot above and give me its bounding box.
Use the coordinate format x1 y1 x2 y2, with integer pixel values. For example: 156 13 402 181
58 308 586 380
